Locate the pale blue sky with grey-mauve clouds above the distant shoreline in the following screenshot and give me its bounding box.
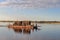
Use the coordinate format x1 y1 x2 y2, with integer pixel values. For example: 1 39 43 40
0 0 60 21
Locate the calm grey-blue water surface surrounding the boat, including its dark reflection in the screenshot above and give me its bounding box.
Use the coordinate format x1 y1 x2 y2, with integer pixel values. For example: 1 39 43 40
0 24 60 40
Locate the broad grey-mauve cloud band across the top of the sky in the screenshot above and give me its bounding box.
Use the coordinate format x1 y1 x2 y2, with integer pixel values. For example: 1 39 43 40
0 0 60 8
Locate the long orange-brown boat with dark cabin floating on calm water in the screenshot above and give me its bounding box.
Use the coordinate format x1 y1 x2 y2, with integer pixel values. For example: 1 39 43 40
8 21 33 30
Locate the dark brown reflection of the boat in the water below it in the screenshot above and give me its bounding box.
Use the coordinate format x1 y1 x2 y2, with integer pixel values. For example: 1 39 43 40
8 27 40 34
